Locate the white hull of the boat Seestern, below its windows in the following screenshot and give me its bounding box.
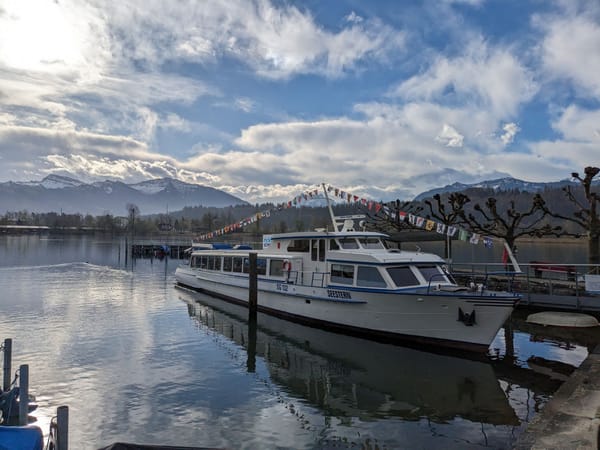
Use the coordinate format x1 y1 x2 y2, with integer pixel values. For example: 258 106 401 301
175 266 518 352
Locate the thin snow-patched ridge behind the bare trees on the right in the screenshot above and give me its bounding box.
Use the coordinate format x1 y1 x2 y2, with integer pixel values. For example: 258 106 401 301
414 178 579 201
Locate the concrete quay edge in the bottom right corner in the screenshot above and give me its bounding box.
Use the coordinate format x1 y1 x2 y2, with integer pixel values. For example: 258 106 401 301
514 345 600 450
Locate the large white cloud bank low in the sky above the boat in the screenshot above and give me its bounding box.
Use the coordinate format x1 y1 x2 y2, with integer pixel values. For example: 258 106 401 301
230 104 516 195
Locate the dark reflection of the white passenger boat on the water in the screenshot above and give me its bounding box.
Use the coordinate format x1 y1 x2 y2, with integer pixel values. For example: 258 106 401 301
176 293 519 425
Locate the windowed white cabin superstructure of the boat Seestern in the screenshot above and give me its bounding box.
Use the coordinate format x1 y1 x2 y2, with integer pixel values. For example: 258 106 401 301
190 231 455 290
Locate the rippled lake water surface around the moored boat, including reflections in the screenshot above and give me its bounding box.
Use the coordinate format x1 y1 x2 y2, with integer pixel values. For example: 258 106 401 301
0 236 597 450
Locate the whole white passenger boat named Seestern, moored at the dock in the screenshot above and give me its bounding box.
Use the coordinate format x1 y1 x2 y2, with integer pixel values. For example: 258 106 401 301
175 202 519 351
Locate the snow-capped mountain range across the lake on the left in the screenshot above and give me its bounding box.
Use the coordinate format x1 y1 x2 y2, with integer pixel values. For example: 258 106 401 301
0 175 247 216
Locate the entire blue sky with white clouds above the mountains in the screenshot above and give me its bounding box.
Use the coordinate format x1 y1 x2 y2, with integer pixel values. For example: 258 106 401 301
0 0 600 202
